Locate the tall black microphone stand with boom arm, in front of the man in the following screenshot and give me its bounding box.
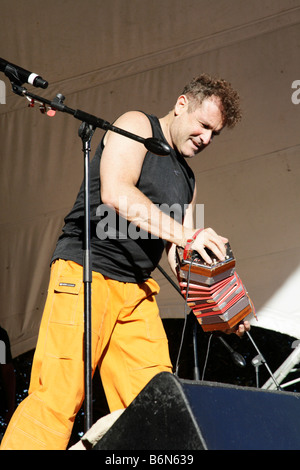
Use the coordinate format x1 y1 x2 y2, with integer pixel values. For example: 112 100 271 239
9 76 171 432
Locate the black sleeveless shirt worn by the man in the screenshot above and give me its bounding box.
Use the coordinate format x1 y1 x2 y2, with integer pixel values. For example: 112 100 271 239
52 115 195 283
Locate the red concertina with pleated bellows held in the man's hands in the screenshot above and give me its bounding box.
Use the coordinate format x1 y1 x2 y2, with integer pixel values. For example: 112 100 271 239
176 243 254 331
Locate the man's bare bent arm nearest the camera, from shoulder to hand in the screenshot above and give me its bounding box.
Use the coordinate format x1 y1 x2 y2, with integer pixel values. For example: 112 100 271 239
100 111 226 262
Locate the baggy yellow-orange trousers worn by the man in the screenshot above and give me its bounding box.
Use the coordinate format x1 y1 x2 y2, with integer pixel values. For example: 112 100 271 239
1 260 172 450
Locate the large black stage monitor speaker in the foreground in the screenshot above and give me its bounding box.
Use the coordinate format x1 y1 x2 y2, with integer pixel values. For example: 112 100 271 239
93 372 300 451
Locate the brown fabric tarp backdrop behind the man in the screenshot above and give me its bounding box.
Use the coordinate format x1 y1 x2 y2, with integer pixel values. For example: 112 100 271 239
0 0 300 356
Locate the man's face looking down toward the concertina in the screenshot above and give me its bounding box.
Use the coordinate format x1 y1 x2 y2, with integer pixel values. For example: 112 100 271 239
170 95 223 157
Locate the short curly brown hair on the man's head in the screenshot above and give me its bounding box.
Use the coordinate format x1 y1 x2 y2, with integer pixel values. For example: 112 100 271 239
182 74 242 128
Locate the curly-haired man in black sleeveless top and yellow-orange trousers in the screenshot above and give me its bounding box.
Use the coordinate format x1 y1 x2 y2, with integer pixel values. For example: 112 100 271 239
2 75 248 449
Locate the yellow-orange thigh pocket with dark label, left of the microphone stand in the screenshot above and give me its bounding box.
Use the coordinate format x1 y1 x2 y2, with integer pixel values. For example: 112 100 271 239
50 276 84 325
